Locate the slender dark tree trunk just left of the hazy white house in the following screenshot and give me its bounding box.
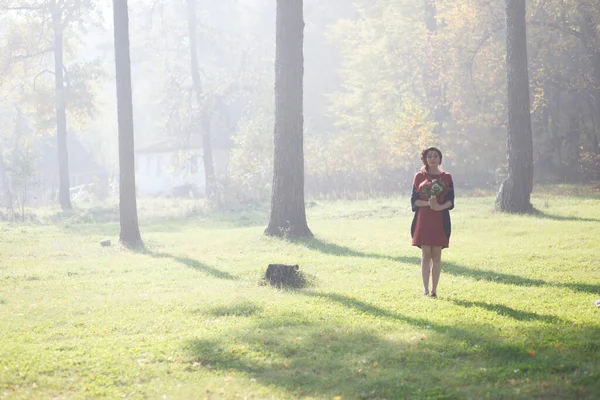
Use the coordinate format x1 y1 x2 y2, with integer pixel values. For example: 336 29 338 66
113 0 143 247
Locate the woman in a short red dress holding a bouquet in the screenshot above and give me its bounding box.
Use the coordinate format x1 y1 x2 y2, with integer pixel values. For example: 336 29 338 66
410 147 454 297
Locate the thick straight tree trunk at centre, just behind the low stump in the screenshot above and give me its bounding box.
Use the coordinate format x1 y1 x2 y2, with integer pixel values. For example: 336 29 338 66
265 0 312 237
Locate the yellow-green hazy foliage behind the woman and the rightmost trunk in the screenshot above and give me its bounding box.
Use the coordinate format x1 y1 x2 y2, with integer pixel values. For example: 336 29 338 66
329 0 600 192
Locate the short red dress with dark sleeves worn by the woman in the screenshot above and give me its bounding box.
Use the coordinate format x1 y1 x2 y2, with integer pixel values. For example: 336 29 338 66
410 171 454 248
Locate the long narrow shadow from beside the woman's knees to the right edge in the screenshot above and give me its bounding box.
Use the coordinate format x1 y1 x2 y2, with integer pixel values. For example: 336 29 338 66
443 262 600 294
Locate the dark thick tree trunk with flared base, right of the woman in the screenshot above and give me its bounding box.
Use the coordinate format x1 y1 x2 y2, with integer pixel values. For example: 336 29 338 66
496 0 533 213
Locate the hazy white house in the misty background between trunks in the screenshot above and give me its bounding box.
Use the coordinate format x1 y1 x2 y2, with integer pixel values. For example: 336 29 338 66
135 137 229 197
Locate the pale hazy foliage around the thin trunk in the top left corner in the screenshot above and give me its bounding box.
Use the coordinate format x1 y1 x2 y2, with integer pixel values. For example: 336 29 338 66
0 0 104 132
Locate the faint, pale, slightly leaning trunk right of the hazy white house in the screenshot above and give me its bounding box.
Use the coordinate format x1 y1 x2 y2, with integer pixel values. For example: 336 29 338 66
186 0 217 199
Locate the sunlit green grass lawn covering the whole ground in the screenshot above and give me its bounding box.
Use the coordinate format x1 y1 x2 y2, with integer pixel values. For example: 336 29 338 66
0 192 600 399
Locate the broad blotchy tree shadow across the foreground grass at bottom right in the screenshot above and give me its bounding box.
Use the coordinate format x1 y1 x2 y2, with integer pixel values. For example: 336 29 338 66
188 291 598 399
